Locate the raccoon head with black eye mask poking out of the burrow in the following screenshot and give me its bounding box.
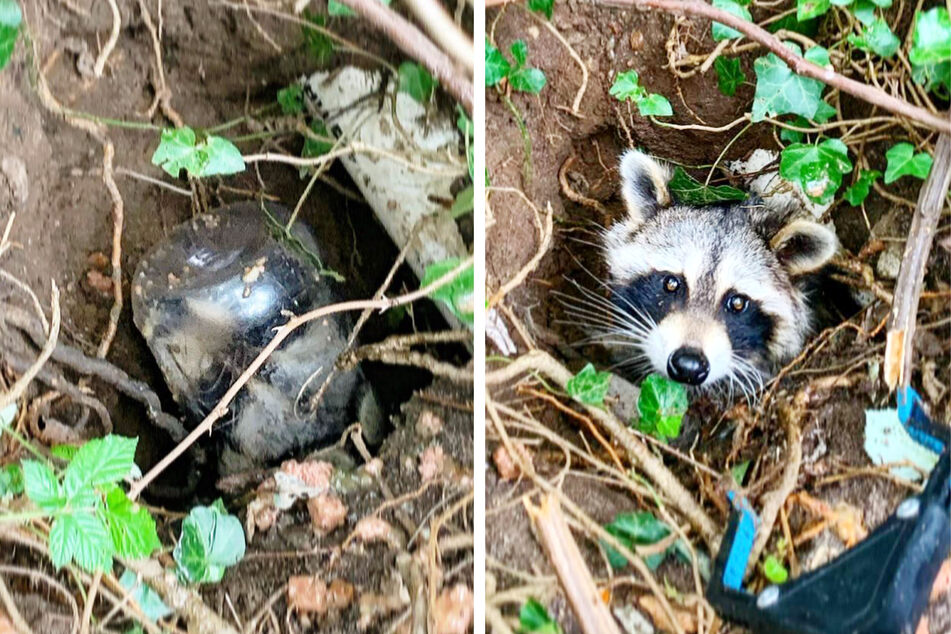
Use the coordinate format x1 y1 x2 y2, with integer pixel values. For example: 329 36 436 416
603 151 838 393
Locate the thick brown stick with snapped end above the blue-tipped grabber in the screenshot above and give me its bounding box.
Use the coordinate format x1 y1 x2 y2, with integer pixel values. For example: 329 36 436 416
885 134 951 390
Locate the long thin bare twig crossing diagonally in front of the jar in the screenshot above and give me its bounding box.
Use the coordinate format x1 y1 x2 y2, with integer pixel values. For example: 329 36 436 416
129 255 473 500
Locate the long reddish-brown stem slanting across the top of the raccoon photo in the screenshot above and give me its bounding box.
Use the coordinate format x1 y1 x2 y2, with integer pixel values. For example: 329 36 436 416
599 0 951 134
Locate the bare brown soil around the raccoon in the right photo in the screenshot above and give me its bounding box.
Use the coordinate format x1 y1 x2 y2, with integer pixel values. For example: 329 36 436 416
486 2 951 632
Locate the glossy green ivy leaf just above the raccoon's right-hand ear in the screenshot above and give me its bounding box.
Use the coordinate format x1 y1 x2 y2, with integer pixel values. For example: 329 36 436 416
779 139 852 205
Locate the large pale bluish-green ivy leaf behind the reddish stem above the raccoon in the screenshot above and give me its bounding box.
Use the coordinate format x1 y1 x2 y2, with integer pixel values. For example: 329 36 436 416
752 42 829 121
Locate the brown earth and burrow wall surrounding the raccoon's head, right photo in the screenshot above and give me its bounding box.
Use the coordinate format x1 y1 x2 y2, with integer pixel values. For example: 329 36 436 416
486 2 951 632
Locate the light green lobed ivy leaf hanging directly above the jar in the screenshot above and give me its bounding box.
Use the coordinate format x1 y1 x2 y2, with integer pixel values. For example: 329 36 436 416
152 127 245 178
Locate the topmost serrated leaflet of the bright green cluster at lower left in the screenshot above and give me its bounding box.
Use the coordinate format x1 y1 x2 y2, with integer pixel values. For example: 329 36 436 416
63 434 138 499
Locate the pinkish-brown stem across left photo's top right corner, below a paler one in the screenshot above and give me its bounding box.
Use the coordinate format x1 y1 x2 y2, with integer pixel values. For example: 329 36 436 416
341 0 474 115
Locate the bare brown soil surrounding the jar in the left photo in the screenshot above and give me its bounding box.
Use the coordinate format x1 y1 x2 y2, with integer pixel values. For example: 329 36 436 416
0 0 473 632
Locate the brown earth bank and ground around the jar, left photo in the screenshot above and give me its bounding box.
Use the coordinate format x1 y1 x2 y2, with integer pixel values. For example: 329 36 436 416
0 0 472 632
